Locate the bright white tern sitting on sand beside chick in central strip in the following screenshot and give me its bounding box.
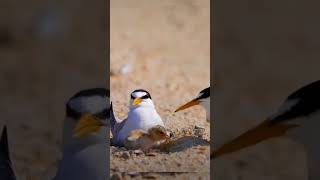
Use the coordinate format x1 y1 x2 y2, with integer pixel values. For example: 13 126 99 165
110 89 164 146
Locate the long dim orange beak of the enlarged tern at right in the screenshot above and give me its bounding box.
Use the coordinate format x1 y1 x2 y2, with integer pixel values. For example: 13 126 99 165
210 120 299 159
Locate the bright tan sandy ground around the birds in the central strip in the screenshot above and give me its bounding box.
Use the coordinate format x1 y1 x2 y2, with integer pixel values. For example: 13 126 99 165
110 0 210 179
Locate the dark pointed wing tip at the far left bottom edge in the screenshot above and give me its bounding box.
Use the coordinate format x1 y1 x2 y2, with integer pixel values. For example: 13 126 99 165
0 126 17 180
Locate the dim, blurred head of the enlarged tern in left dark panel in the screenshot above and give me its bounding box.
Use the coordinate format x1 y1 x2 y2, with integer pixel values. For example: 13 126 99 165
66 88 109 138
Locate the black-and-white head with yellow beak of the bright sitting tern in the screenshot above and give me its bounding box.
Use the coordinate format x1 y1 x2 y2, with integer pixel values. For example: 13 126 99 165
130 89 154 109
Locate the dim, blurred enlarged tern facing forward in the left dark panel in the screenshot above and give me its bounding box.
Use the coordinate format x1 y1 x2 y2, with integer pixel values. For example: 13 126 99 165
54 88 109 180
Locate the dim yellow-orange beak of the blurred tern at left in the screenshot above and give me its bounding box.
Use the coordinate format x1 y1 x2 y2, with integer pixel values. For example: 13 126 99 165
73 113 105 137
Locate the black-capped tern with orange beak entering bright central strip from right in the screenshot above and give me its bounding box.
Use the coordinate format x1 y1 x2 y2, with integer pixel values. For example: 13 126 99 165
175 87 210 122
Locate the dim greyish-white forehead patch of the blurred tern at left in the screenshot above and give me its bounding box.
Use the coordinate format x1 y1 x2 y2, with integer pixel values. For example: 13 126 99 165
69 96 107 114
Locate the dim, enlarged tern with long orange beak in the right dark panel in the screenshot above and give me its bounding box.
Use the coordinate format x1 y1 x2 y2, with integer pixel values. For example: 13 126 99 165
211 81 320 180
